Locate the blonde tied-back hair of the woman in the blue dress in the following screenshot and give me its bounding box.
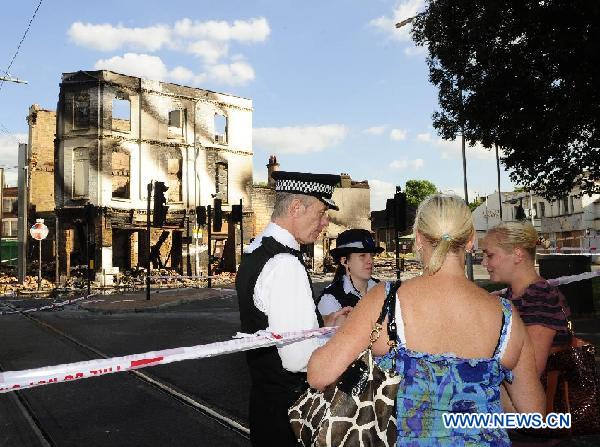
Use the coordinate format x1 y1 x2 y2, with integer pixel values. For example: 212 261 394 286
413 194 475 274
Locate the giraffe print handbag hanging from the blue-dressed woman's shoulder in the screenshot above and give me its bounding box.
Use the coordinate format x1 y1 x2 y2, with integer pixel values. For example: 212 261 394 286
288 282 400 447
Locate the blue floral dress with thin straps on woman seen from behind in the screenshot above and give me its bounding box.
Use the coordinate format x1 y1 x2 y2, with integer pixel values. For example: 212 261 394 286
379 286 512 447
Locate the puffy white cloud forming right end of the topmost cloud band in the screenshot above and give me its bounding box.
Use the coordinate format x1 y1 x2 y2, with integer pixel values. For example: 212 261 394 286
173 17 271 42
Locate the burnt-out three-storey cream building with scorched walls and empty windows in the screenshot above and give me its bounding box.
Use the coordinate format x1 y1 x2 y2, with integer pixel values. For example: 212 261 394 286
53 70 252 278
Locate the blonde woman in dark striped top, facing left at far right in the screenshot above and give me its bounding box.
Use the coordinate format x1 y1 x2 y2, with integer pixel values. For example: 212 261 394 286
482 222 570 375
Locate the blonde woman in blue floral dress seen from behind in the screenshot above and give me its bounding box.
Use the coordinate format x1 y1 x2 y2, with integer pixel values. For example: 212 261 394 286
308 195 545 446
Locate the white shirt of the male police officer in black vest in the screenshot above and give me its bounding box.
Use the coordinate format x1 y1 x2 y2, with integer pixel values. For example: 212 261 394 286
245 222 327 372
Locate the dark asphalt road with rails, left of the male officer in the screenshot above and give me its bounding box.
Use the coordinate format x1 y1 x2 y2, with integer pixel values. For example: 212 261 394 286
0 298 250 446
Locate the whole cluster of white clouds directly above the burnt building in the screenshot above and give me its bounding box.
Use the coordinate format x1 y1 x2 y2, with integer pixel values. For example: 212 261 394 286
68 17 271 86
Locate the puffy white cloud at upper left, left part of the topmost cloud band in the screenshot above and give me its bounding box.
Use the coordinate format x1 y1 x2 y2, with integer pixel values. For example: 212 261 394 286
67 22 171 51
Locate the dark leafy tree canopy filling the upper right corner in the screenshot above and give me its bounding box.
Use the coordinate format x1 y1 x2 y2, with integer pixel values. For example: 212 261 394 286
413 0 600 199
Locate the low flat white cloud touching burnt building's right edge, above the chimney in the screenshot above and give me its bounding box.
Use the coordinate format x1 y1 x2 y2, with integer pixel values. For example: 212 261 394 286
253 124 348 154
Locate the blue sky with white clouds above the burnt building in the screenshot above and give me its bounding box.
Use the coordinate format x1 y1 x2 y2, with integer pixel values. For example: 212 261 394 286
0 0 512 209
